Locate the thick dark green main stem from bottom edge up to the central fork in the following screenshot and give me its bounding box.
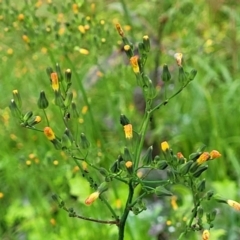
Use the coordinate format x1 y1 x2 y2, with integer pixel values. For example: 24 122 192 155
118 180 134 240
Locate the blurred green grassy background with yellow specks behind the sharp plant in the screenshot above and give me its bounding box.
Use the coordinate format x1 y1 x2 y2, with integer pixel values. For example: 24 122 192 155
0 0 240 240
